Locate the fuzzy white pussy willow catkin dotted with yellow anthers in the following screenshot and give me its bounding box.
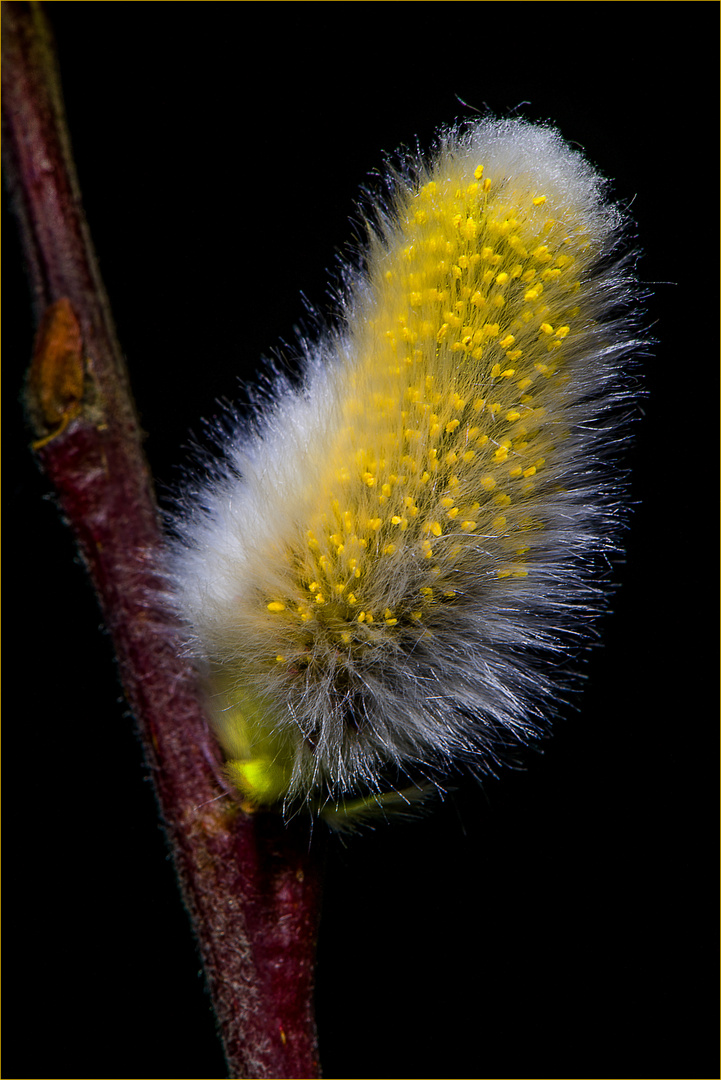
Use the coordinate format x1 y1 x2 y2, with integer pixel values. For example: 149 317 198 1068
172 120 638 820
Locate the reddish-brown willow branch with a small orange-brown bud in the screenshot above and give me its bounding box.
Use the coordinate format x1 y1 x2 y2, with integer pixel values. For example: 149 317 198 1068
2 2 321 1077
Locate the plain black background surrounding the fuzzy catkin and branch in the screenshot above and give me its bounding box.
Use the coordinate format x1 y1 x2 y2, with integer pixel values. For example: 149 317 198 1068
3 3 718 1077
